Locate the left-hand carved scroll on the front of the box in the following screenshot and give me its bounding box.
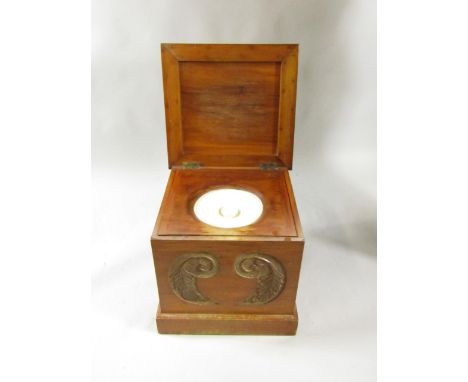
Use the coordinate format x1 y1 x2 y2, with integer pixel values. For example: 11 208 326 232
169 253 219 305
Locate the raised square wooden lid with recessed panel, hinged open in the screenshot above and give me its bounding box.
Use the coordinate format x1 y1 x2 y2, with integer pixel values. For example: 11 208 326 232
161 44 298 169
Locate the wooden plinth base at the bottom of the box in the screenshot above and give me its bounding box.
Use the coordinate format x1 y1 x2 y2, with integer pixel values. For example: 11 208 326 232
156 306 298 336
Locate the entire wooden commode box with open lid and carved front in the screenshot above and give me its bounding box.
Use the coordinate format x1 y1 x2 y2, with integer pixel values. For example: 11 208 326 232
151 44 304 335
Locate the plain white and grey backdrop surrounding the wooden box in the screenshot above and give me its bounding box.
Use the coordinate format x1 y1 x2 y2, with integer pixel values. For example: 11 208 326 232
92 0 376 382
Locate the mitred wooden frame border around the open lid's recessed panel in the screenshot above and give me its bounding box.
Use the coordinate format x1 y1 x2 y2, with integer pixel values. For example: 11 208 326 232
161 44 299 169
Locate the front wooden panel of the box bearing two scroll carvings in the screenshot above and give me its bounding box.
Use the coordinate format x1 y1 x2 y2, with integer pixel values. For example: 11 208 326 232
152 238 304 314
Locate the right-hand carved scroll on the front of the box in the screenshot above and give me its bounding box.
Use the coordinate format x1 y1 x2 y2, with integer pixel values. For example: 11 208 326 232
234 254 286 305
